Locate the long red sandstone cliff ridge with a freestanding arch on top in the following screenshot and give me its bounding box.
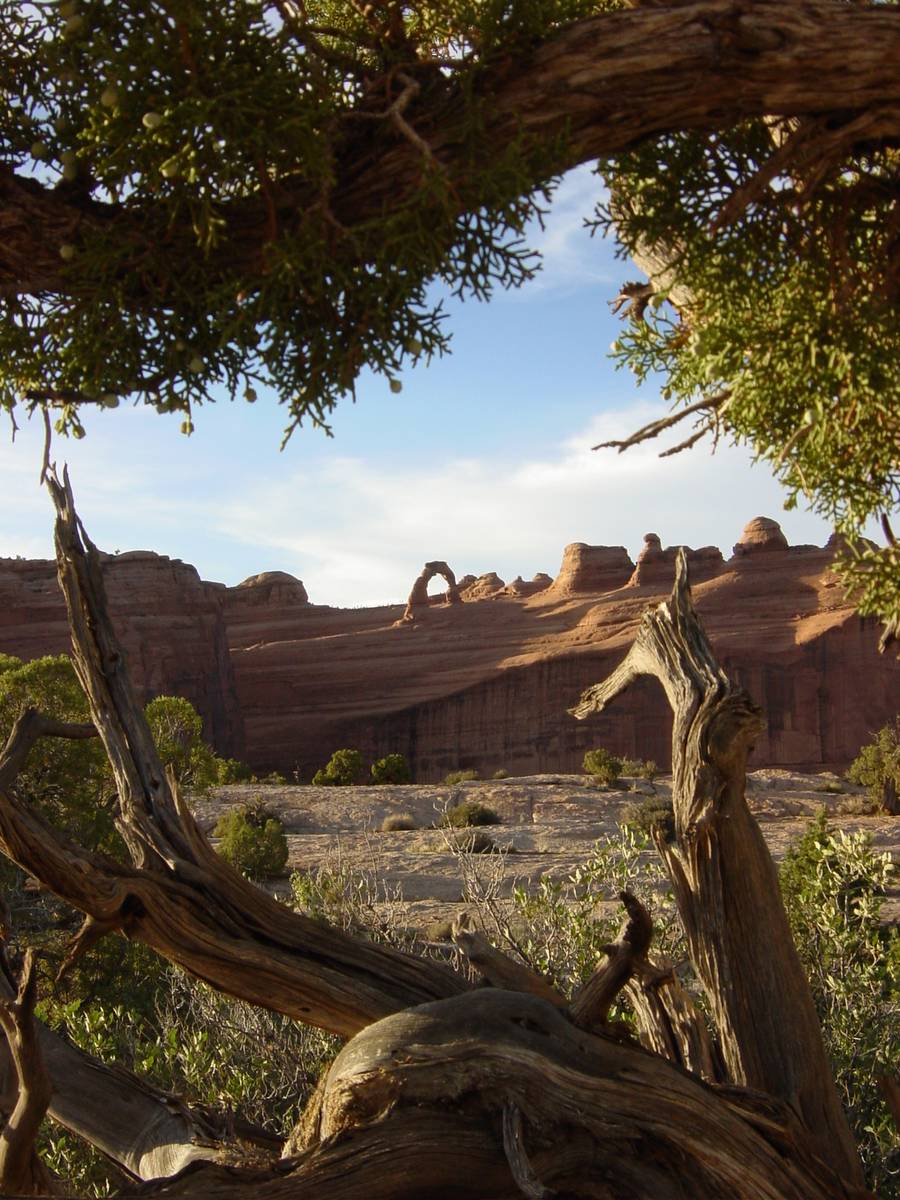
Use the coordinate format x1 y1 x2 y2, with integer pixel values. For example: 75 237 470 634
0 517 900 782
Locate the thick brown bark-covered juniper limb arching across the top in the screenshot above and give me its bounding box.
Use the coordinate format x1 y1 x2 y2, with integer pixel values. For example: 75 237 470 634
0 0 900 295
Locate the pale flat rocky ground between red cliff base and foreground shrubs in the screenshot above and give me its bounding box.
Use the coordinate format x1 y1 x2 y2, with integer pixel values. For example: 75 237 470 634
194 768 900 929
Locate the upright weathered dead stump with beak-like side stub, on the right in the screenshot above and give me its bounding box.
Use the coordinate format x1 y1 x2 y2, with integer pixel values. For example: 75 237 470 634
572 551 862 1184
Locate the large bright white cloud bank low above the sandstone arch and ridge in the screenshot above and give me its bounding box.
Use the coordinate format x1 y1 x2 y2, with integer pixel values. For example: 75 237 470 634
204 403 828 606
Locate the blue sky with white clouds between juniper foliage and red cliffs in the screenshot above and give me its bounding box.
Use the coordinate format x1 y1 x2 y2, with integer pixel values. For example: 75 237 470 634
0 167 829 607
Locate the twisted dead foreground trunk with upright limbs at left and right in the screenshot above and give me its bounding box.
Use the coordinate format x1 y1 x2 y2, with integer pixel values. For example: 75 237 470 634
0 485 869 1200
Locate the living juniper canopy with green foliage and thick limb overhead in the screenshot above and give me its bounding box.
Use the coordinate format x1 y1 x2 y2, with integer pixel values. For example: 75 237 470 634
0 0 900 622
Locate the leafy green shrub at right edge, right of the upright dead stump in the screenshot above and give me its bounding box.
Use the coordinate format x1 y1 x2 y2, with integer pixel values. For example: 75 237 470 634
780 814 900 1198
